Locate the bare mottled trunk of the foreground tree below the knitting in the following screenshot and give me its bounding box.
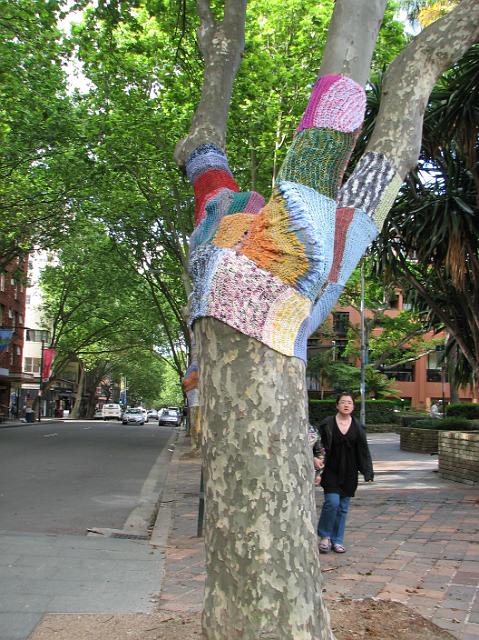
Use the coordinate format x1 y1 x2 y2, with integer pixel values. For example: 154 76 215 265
196 318 333 640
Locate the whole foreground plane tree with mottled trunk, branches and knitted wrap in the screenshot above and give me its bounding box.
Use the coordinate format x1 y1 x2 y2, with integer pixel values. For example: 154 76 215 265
175 0 479 640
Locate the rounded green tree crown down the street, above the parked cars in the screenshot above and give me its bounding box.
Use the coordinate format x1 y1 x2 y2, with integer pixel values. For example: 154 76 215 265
38 221 184 407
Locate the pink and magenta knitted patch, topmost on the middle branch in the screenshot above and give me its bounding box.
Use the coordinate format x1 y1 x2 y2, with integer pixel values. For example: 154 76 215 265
296 75 366 133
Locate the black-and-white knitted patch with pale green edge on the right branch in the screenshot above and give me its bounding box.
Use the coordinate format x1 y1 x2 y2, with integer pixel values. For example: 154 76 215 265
338 151 402 229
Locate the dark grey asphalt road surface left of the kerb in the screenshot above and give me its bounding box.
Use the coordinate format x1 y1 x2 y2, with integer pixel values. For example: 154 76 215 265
0 421 172 535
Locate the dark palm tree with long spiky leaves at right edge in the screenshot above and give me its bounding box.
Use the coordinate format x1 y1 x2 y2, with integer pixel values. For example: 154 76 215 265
378 45 479 396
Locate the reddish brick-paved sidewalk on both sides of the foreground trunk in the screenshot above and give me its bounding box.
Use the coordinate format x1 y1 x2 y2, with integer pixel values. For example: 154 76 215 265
159 434 479 640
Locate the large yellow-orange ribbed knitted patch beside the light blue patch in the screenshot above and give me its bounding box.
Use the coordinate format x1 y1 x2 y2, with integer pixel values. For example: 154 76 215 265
241 191 309 285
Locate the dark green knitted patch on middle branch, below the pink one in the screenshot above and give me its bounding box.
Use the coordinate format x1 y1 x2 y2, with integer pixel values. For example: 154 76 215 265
278 129 356 199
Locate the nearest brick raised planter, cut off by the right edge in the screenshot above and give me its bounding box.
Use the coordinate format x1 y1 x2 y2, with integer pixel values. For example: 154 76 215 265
439 431 479 486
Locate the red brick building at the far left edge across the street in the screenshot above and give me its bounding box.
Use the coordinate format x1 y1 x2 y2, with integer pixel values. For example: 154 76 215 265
0 259 28 417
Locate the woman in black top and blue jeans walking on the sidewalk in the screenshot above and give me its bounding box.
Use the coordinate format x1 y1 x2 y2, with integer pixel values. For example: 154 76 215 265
314 393 374 553
